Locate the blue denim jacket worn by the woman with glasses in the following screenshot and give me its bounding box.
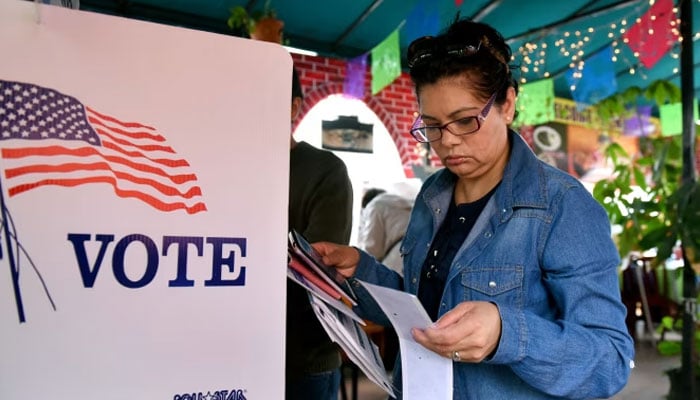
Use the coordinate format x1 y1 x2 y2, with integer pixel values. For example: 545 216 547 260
354 131 634 400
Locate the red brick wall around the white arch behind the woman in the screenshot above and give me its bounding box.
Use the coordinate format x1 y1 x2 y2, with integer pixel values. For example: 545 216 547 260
292 54 439 177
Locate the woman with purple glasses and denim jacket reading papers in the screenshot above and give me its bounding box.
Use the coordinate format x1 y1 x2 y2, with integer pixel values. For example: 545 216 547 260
315 20 634 399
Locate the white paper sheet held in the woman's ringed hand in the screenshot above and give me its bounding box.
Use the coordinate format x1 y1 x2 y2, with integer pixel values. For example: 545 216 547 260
358 280 452 400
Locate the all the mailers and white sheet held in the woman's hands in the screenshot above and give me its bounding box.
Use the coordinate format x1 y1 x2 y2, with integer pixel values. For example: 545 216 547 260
287 232 452 400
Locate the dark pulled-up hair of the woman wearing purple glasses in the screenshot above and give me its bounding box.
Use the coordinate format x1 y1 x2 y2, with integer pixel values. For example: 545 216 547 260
407 19 518 104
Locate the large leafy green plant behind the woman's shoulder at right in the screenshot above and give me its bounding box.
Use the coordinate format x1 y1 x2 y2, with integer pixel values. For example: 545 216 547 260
593 81 700 398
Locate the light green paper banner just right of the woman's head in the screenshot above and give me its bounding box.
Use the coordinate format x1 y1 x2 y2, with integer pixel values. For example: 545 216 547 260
516 79 554 125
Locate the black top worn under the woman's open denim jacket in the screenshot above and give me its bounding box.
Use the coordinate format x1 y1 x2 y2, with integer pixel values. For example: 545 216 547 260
418 185 498 321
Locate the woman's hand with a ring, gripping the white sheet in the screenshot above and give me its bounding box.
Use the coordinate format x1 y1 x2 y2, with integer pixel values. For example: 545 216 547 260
412 301 501 363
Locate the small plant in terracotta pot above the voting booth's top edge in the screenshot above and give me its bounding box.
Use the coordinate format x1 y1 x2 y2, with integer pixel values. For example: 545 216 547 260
226 0 284 44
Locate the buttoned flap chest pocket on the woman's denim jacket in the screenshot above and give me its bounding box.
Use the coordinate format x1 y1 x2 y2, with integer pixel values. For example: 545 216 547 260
462 265 524 307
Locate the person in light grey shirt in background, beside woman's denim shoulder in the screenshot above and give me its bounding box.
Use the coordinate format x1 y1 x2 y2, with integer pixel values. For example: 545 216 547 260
357 188 413 276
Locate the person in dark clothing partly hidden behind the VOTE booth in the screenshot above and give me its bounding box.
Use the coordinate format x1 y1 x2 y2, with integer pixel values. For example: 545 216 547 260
285 66 353 400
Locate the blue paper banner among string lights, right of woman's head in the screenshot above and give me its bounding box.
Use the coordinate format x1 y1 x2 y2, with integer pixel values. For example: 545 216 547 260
566 46 617 110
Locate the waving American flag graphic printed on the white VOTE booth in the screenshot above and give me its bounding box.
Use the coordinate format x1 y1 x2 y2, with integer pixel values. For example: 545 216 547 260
0 80 207 214
